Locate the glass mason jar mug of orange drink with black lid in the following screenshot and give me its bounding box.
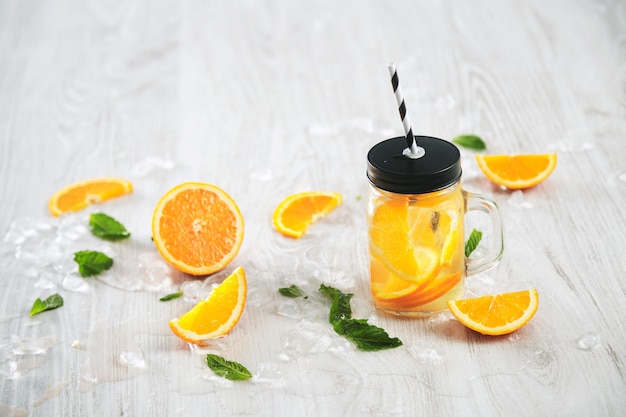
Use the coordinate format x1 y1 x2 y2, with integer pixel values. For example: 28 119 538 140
367 136 503 316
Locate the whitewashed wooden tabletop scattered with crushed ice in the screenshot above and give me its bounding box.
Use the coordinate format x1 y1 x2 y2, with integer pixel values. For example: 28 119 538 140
0 0 626 416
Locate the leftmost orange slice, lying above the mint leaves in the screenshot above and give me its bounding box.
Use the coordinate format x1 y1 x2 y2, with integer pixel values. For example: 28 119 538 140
48 177 133 216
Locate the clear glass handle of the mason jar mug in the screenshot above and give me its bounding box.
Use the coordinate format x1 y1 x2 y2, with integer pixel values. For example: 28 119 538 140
463 191 504 276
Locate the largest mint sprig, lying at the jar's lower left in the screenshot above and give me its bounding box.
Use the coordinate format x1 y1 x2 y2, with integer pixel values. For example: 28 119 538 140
320 284 402 352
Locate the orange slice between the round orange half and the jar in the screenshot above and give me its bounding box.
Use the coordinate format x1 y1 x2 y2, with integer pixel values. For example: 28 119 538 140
273 191 341 239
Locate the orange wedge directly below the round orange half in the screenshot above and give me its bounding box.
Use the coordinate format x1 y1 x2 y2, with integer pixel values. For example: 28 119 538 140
169 267 248 346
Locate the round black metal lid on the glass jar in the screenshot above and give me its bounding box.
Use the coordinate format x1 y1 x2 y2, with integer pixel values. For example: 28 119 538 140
367 136 461 194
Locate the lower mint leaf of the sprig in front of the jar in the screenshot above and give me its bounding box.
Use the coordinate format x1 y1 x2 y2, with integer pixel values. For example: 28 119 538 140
333 319 402 352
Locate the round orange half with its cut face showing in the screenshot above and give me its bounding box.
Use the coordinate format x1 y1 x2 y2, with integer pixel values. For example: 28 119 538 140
152 182 243 275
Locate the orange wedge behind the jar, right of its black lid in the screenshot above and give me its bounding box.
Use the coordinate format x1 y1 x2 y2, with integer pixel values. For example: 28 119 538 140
476 153 557 190
